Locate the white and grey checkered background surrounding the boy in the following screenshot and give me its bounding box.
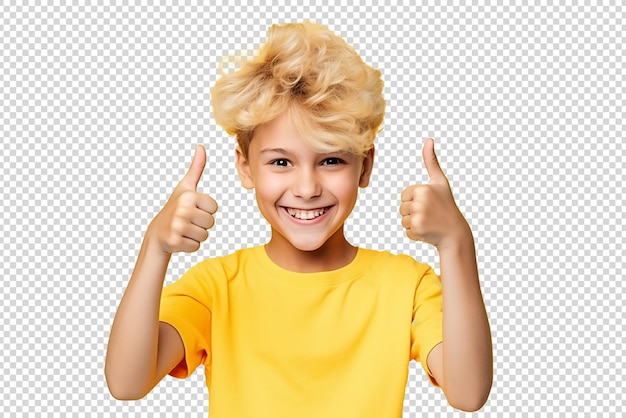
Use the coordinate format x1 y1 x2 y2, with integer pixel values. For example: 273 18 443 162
0 1 626 417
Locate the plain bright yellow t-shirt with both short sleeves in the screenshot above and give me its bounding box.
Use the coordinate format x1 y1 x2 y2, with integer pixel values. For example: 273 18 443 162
160 246 442 418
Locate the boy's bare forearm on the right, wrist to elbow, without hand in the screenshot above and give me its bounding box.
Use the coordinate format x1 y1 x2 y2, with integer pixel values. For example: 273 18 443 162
439 227 493 410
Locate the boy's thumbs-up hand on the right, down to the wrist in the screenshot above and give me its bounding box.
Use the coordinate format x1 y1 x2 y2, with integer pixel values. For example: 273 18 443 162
400 138 471 250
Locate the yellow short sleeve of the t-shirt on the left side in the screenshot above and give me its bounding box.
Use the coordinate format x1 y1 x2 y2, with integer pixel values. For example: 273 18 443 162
159 271 211 378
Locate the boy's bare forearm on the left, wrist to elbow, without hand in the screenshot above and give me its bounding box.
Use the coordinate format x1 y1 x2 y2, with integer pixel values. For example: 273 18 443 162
105 230 170 398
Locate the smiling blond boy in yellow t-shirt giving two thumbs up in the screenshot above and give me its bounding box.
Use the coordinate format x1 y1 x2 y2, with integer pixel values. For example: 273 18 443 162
105 23 492 418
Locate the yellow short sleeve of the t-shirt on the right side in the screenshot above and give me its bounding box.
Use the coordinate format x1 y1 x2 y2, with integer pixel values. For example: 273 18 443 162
411 268 443 384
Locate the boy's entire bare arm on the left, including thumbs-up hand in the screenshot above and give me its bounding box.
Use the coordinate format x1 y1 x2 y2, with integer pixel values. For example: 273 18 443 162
105 145 217 399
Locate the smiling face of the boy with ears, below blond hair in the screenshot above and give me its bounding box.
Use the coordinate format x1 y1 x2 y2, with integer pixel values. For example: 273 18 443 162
237 115 374 260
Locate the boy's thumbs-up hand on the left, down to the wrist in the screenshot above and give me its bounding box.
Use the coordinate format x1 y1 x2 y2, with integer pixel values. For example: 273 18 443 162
146 145 217 254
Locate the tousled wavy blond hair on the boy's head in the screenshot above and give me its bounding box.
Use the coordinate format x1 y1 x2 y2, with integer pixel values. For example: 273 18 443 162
211 22 385 158
